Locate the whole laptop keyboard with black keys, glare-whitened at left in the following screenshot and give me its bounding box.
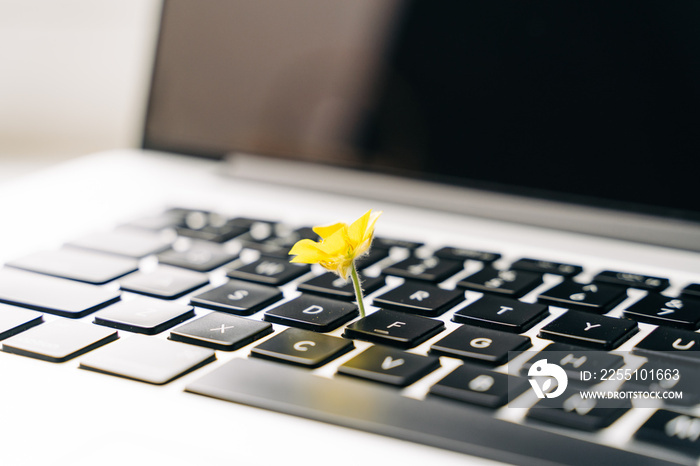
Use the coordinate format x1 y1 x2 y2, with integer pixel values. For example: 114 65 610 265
0 208 700 464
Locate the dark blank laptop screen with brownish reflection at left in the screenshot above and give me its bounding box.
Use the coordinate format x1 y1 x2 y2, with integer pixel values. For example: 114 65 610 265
144 0 700 225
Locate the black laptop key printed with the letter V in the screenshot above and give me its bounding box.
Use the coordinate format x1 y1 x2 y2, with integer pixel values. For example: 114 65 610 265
338 345 440 387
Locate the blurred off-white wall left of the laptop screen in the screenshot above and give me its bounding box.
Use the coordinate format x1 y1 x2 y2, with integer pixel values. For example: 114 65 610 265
0 0 160 177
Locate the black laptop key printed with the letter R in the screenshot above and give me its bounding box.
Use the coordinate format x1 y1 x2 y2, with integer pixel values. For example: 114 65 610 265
373 281 464 317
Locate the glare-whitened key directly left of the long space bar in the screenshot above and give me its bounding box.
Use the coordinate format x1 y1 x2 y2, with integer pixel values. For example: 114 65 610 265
80 335 216 385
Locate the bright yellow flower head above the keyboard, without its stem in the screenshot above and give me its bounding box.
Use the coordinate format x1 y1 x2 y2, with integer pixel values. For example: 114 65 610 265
289 210 382 280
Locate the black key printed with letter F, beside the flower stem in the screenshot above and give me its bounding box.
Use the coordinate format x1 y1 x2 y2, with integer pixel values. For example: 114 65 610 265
343 309 445 349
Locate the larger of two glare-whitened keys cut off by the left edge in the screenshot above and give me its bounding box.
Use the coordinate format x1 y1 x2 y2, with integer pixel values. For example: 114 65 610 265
0 269 119 317
